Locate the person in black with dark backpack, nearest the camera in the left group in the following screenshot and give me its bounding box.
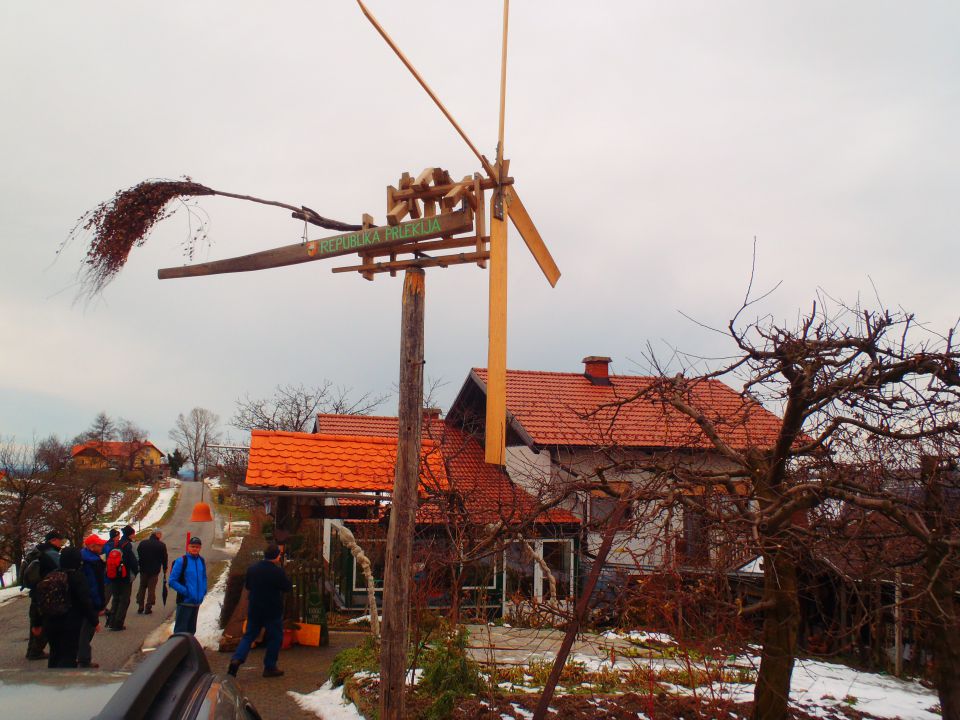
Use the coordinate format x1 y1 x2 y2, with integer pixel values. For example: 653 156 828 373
37 547 100 668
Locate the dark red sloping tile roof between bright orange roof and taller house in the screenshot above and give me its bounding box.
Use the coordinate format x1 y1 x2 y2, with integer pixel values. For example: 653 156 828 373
317 414 580 524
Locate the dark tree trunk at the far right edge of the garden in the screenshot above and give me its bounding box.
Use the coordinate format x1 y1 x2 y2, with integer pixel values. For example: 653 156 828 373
924 542 960 720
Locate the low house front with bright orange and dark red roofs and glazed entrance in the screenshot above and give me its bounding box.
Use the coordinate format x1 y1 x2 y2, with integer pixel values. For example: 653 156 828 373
245 411 579 616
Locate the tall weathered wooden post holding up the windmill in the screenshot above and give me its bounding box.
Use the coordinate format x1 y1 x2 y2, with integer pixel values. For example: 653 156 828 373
380 268 424 720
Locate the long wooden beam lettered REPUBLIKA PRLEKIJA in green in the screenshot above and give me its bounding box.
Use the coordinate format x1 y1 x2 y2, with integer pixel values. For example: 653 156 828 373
157 209 473 280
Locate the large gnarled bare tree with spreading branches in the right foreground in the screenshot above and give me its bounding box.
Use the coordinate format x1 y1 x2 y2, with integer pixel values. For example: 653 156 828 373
631 298 960 720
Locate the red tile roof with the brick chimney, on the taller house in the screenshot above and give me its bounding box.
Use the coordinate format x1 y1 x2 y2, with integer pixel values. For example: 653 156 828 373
472 368 780 449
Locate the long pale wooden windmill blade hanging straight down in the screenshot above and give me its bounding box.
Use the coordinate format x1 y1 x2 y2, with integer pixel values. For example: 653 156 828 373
484 213 507 465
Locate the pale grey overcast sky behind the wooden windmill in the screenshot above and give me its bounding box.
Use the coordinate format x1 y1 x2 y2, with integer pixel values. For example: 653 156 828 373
0 0 960 451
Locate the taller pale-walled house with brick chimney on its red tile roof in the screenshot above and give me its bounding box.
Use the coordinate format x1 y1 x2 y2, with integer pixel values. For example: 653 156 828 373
447 356 780 575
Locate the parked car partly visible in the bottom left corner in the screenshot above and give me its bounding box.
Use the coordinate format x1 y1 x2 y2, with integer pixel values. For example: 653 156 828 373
0 633 260 720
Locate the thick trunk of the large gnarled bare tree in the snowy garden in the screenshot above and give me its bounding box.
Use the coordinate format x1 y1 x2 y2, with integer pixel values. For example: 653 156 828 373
753 541 800 720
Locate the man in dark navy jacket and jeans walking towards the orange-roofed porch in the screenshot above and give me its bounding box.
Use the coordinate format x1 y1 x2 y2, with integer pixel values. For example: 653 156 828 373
227 545 293 677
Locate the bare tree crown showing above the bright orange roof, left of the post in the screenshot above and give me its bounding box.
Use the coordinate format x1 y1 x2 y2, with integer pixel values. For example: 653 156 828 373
230 380 384 432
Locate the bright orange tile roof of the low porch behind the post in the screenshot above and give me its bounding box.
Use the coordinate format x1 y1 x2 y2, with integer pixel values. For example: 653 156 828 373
246 430 447 492
